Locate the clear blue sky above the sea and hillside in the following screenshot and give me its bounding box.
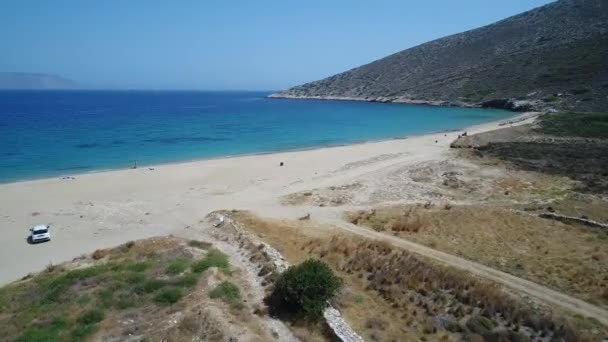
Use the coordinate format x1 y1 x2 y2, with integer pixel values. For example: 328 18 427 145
0 0 551 90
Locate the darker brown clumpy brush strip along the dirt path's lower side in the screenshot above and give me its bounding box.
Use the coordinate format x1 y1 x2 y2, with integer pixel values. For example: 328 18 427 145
307 236 577 339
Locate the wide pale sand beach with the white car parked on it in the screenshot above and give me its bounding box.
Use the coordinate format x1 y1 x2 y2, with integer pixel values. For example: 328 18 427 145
0 113 533 284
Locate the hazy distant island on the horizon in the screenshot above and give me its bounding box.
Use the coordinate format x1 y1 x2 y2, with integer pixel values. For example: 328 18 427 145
0 72 80 90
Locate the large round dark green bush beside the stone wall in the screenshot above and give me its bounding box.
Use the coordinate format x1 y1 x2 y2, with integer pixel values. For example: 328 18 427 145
266 259 342 320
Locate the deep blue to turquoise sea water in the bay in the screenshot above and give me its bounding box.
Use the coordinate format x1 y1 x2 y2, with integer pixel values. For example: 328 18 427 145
0 91 510 182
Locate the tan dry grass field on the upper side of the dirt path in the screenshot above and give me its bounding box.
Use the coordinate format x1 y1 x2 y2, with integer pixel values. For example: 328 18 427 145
346 206 608 305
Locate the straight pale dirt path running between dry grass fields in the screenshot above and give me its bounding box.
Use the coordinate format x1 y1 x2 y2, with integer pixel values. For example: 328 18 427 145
327 219 608 326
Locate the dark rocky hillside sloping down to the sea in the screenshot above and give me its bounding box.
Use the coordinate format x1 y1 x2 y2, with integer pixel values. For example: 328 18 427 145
271 0 608 111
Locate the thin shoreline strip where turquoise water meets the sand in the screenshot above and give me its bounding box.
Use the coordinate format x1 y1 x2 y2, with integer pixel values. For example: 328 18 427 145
0 113 524 186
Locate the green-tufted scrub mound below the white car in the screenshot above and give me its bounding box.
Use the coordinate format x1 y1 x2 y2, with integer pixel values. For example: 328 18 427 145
0 238 233 342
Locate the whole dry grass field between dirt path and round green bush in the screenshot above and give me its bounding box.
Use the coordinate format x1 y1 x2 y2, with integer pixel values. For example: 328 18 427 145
228 213 596 341
